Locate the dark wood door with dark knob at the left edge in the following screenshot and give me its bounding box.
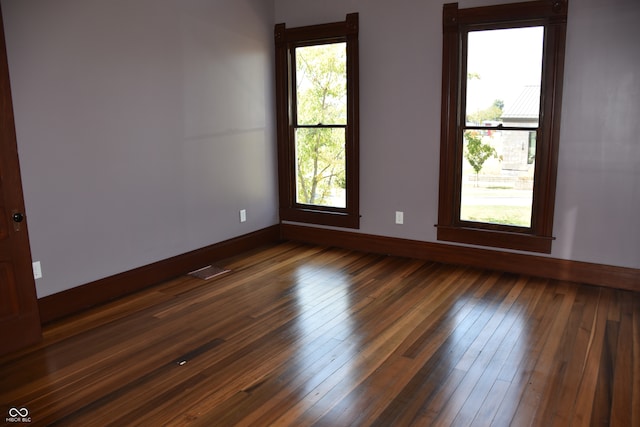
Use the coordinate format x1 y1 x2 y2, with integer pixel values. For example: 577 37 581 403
0 5 42 355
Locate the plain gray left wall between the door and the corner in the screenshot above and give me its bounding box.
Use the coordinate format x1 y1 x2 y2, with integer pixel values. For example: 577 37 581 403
2 0 278 297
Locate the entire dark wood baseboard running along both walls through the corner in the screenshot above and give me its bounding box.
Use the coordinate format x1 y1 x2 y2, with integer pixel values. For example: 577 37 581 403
38 224 640 323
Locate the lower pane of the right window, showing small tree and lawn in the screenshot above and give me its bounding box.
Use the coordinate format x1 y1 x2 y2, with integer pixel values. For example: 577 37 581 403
460 130 536 227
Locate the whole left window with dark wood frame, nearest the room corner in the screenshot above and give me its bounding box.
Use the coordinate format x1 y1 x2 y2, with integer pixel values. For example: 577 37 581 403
275 13 360 228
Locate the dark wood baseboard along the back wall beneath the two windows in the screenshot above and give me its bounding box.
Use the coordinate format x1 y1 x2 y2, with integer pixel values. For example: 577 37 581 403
281 224 640 292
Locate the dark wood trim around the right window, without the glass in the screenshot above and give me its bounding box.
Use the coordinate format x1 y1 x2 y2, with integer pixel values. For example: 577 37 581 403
437 0 567 253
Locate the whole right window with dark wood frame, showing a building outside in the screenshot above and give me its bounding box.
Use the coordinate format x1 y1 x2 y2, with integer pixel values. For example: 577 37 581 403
437 0 567 253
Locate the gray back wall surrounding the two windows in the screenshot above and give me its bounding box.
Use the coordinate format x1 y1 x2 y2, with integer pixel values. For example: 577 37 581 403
275 0 640 268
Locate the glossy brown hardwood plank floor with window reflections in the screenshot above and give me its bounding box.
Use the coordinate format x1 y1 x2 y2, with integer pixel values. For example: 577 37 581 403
0 243 640 426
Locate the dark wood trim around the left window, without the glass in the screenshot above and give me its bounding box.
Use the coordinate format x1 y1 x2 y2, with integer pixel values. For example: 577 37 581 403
275 13 360 228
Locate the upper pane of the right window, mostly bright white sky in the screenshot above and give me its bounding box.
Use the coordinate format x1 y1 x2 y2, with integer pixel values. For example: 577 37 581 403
466 27 544 127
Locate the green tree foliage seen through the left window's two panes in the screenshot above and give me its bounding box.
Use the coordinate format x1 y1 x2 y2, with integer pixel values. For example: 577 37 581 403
296 43 347 206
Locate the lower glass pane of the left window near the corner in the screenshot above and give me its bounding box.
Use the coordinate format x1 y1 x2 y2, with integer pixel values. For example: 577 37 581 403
295 128 347 208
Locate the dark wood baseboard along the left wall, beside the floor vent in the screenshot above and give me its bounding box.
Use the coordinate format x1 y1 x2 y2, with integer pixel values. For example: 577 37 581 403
38 225 280 323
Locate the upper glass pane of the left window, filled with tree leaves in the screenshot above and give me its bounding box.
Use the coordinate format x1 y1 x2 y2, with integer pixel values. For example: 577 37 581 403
295 43 347 125
